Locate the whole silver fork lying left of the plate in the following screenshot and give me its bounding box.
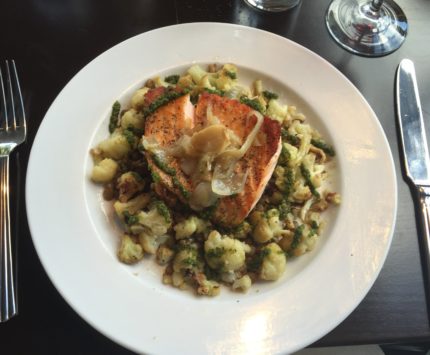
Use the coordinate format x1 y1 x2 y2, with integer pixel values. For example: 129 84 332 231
0 60 27 322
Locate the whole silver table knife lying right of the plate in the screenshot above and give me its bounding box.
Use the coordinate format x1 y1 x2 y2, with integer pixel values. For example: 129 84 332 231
396 59 430 306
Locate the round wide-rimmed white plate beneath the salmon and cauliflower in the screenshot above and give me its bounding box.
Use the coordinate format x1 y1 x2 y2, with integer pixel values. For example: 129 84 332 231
26 23 397 354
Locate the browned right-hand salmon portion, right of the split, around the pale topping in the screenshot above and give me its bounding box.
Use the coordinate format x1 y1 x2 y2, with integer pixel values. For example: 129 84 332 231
195 93 281 226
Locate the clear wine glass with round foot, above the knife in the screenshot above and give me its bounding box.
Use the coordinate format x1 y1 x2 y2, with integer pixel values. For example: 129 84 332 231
326 0 408 57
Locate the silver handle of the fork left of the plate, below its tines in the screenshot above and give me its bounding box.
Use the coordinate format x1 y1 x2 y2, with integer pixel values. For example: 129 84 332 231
0 156 18 322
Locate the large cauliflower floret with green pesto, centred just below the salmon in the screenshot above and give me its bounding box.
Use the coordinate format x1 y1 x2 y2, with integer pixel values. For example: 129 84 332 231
204 231 251 272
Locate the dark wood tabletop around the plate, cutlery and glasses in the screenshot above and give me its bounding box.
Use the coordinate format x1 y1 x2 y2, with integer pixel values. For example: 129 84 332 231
0 0 430 354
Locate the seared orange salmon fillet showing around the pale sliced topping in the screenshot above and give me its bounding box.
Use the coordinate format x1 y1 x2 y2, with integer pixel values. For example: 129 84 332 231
145 88 281 226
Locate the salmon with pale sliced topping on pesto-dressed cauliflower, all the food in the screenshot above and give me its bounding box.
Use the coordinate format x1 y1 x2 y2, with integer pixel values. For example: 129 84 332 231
91 64 340 296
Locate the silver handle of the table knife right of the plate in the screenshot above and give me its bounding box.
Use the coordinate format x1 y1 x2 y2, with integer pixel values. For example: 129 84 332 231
418 186 430 290
